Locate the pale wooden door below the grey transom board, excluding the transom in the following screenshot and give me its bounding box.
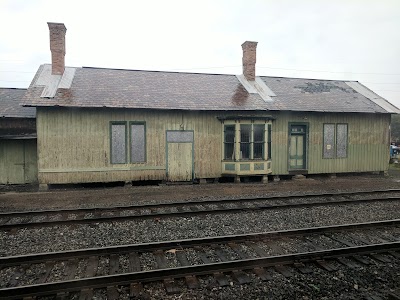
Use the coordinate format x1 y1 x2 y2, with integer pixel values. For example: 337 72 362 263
167 143 193 181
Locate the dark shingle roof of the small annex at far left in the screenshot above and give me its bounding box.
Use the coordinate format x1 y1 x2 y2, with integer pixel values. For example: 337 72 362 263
0 88 36 118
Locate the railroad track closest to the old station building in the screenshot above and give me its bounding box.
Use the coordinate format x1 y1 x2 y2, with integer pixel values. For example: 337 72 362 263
0 189 400 230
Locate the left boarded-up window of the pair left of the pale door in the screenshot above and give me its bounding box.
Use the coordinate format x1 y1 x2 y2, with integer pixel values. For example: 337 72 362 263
111 123 126 164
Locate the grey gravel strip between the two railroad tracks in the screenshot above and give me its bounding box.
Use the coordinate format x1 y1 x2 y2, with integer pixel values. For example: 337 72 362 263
0 202 400 256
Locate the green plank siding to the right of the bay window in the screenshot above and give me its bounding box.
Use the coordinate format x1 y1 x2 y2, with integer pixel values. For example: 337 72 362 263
272 113 390 175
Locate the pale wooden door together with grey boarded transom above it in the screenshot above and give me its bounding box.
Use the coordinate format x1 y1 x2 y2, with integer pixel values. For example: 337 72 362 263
167 130 193 181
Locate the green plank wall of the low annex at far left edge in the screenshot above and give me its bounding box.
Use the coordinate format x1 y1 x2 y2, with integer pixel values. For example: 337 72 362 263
0 139 37 184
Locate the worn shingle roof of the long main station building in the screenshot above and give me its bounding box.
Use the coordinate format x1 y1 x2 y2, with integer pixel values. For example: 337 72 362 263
23 65 398 113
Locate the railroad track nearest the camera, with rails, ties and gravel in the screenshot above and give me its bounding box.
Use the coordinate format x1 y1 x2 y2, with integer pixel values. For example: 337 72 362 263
0 219 400 299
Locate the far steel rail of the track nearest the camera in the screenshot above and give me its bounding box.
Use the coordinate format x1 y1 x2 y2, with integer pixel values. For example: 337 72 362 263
0 219 400 267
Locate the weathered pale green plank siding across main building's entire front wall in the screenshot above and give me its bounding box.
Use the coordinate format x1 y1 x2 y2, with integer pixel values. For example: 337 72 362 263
37 107 390 184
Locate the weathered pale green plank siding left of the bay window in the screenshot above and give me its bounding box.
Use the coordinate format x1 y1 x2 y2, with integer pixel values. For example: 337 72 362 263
37 108 221 184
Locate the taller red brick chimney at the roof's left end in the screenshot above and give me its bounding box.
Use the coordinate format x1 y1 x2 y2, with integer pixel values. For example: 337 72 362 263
47 23 67 75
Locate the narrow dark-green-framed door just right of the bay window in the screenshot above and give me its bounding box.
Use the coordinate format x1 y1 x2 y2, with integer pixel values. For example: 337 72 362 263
289 124 307 170
